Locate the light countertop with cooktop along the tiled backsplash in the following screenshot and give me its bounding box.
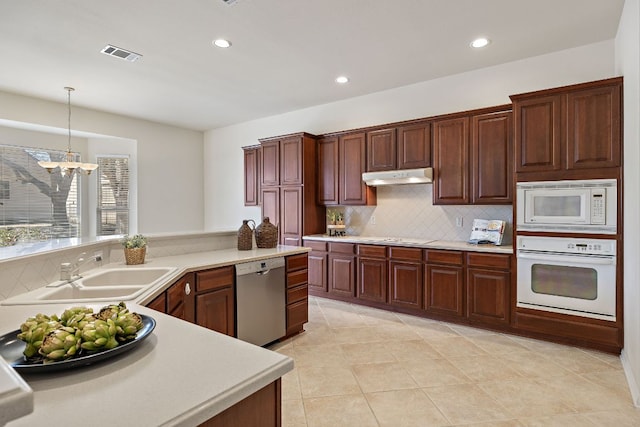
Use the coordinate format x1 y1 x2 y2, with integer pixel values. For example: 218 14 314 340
303 234 513 254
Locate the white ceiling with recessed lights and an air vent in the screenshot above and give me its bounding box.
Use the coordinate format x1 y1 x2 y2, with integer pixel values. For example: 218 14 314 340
0 0 624 130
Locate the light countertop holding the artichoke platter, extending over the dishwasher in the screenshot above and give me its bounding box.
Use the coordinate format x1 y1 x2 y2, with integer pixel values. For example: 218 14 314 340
0 246 308 426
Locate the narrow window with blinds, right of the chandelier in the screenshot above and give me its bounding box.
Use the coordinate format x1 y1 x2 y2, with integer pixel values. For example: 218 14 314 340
96 156 129 236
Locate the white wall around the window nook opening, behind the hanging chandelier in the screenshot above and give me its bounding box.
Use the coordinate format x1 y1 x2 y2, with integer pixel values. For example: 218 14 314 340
0 92 204 233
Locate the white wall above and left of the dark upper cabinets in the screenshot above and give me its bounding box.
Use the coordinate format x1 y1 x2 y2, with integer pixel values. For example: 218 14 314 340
204 40 616 230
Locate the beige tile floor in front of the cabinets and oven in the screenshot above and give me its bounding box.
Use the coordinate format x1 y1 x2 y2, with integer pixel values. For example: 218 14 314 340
272 297 640 427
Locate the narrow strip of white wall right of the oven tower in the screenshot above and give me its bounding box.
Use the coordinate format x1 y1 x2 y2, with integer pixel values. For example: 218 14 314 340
616 0 640 406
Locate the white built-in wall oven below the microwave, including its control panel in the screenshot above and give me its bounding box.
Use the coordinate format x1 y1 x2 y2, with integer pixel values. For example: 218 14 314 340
516 236 616 322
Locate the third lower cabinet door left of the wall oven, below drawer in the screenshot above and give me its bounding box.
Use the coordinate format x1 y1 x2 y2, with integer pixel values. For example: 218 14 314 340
389 260 423 308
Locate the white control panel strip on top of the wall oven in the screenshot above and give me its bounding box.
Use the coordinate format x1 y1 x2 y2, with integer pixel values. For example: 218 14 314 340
516 236 616 256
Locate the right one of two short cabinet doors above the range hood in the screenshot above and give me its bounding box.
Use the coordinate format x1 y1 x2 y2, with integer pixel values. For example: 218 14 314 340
397 123 431 169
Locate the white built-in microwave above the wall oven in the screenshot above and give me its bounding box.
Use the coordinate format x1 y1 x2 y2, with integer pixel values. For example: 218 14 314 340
516 179 618 234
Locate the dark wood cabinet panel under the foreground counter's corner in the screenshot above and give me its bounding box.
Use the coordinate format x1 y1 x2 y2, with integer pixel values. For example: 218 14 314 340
200 378 282 427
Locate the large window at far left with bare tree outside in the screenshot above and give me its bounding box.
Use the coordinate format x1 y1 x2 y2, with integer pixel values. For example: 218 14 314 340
0 145 80 246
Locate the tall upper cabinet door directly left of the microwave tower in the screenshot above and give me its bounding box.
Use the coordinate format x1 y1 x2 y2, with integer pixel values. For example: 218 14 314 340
471 111 513 204
